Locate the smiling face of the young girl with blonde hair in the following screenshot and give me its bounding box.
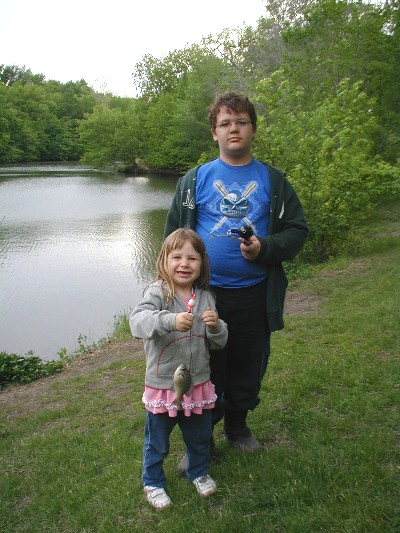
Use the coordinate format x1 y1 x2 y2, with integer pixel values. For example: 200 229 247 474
167 241 202 291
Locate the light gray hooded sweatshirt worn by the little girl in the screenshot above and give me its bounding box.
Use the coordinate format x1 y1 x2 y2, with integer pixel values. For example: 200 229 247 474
129 282 228 389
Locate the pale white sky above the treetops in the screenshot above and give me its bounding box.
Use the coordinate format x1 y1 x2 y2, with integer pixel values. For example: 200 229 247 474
0 0 265 97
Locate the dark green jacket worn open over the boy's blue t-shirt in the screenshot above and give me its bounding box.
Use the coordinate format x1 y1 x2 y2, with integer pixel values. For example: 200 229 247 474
164 163 308 331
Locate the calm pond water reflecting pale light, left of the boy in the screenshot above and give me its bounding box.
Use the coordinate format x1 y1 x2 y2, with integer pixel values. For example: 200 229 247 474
0 164 176 360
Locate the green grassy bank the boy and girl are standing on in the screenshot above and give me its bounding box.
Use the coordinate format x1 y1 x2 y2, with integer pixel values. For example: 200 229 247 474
0 201 400 533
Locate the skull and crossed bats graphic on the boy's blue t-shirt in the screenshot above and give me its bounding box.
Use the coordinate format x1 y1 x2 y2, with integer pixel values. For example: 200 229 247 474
209 180 258 231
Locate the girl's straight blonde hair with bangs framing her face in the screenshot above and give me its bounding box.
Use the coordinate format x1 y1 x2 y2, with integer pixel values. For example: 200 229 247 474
156 228 210 303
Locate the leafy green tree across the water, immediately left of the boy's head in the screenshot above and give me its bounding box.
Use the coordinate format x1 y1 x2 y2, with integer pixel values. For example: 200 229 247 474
134 45 226 172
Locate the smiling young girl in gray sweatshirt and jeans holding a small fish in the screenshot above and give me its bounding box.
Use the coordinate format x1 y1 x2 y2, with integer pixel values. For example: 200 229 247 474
129 228 228 509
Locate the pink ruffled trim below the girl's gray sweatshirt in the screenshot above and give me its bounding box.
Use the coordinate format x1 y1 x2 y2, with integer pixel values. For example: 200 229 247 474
142 380 217 417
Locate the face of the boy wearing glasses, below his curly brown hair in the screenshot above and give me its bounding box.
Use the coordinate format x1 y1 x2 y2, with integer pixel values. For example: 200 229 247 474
211 106 256 163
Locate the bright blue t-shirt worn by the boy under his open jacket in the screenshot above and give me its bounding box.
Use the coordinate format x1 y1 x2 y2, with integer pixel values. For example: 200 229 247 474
196 158 270 288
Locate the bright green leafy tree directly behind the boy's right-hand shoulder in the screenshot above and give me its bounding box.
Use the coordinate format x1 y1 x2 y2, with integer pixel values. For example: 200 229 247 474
256 71 400 261
